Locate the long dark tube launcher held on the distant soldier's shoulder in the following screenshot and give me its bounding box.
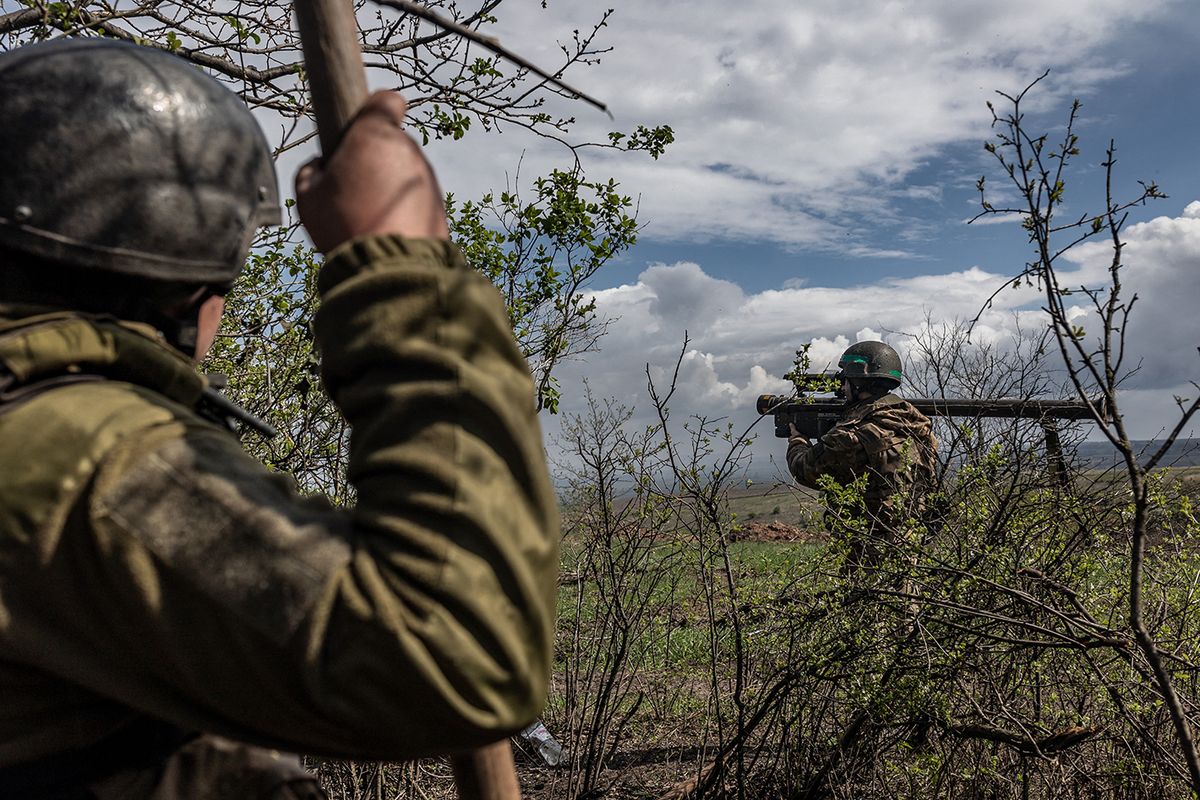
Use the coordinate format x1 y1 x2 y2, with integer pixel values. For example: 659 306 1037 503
757 393 1108 444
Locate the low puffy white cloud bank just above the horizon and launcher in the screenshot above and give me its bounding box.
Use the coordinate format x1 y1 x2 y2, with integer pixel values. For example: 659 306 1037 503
549 201 1200 470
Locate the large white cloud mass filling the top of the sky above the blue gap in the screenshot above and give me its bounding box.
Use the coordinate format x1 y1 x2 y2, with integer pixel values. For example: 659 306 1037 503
427 0 1177 257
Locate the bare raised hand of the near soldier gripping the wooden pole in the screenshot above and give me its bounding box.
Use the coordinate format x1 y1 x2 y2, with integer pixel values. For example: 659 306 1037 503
296 91 450 253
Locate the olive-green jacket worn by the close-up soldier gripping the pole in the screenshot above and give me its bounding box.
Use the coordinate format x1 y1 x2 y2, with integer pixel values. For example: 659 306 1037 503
0 236 559 800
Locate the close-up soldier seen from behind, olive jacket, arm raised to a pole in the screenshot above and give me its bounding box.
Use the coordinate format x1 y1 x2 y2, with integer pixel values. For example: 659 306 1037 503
0 40 558 800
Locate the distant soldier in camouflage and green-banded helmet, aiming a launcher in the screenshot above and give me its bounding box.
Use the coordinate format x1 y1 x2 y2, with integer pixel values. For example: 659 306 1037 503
787 342 937 572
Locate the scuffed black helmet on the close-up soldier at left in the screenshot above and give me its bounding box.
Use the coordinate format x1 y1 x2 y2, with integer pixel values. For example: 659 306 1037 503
0 38 280 287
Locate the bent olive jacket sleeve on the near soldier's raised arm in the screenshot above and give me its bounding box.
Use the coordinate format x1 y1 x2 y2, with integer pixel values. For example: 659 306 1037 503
79 237 559 759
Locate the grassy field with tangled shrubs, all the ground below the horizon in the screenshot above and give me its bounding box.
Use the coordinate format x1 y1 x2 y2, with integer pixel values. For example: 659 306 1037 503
309 468 1200 800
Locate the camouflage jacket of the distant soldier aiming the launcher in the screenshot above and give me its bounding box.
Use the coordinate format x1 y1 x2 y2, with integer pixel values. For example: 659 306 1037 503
787 395 937 527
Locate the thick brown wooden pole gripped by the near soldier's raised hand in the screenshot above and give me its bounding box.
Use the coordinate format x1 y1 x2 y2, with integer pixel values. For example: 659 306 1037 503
294 0 521 800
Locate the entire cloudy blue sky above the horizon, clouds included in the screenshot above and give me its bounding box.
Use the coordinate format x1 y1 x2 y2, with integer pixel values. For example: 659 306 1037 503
415 0 1200 465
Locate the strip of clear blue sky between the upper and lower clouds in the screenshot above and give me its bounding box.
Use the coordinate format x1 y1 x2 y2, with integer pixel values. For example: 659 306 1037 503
609 45 1200 291
